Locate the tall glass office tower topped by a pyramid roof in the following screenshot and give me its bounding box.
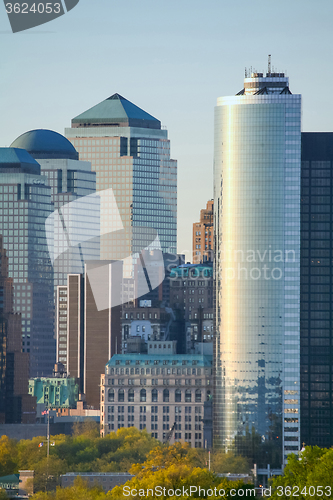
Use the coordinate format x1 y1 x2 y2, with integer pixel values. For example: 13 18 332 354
65 94 177 262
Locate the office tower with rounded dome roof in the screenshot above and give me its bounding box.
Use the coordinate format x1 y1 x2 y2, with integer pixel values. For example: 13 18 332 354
11 129 100 290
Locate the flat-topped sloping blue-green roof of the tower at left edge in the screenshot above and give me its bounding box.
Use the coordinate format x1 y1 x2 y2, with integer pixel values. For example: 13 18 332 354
0 148 40 175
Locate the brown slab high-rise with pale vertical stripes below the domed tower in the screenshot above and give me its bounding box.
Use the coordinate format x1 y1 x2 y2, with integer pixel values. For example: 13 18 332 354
57 261 122 408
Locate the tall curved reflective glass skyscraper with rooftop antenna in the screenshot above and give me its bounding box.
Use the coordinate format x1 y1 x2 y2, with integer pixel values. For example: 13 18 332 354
214 70 301 466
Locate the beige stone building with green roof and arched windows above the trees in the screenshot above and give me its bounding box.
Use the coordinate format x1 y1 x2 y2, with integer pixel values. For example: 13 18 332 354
100 352 212 447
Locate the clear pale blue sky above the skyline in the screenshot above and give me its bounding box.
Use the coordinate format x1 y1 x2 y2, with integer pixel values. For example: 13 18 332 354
0 0 333 258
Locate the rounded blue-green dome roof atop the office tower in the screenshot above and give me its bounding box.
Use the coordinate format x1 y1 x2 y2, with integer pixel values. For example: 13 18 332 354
10 129 79 160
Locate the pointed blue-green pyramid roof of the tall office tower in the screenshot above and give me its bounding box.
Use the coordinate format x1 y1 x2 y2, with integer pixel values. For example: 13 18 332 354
72 94 161 129
